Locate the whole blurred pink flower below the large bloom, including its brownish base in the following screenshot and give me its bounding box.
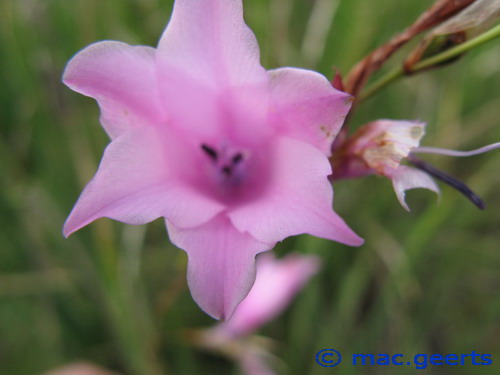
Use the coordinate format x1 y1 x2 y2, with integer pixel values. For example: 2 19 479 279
194 254 320 375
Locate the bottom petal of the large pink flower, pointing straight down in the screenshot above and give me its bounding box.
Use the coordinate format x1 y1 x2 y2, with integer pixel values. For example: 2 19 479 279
167 215 274 319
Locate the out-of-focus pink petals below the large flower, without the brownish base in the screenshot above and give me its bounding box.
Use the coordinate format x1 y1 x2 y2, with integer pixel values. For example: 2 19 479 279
222 254 319 336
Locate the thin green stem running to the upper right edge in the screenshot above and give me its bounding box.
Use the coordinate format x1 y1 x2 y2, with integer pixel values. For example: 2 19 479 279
358 25 500 102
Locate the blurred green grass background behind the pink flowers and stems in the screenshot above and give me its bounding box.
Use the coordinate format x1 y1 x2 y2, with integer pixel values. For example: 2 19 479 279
0 0 500 375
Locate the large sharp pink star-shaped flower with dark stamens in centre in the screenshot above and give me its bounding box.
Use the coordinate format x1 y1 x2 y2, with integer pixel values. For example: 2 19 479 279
63 0 362 319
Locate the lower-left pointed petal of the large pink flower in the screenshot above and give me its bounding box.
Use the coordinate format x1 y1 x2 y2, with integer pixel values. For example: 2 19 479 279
64 128 224 236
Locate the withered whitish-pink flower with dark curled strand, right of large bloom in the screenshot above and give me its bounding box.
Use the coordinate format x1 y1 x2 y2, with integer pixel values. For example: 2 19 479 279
333 120 500 211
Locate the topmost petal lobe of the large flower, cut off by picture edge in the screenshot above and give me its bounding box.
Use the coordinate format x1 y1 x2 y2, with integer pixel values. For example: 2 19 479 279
158 0 266 87
